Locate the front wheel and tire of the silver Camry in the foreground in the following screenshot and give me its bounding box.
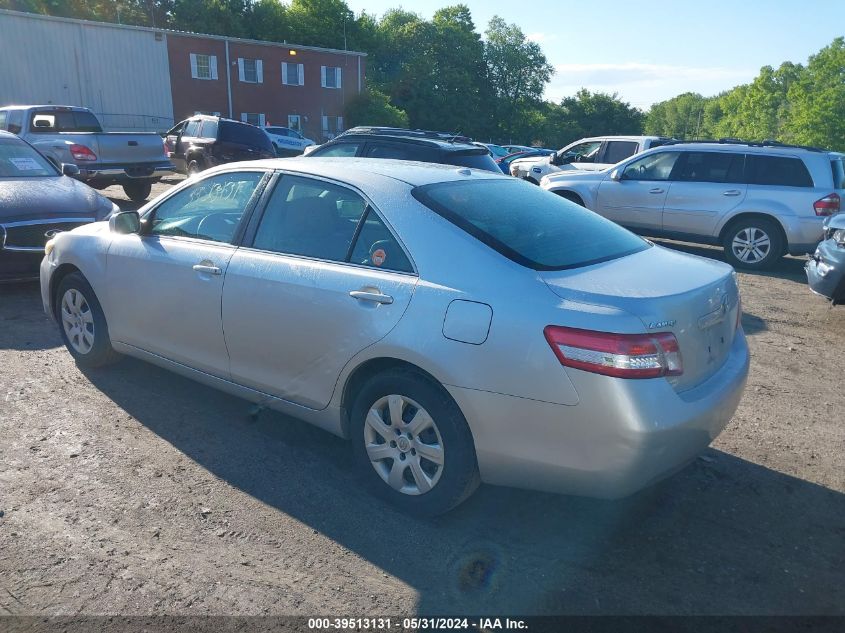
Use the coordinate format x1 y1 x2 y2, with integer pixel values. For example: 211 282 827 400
55 273 120 368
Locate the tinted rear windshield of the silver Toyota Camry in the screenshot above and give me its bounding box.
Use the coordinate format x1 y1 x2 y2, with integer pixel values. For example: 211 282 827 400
413 177 649 270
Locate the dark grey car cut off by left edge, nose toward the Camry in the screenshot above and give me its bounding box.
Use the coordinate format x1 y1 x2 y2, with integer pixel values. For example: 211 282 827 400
0 131 117 282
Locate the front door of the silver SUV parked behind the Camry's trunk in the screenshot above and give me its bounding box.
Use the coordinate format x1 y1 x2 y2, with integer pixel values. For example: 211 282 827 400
596 152 678 231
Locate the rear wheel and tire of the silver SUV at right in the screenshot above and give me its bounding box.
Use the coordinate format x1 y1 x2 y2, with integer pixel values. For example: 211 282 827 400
722 217 784 270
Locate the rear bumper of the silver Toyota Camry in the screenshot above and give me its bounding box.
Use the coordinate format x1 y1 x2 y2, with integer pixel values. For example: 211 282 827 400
449 331 749 498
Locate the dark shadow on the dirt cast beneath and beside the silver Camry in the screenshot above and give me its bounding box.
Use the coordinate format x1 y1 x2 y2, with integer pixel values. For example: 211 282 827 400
84 359 845 615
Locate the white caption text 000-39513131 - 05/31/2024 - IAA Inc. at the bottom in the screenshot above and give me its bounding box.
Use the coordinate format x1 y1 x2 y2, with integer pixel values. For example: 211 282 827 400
308 617 528 631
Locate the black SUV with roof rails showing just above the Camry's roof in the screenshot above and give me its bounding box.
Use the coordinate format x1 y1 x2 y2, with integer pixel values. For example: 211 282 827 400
304 127 501 173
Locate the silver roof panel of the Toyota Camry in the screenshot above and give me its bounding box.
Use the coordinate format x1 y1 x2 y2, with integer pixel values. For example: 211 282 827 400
215 156 512 187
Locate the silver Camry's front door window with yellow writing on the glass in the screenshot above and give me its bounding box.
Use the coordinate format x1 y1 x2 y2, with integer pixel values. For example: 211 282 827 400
148 171 264 242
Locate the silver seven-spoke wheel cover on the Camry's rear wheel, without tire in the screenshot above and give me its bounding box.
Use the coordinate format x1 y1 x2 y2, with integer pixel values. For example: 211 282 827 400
364 394 445 495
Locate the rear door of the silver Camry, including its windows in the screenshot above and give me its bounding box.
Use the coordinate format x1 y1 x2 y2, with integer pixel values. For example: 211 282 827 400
223 175 417 409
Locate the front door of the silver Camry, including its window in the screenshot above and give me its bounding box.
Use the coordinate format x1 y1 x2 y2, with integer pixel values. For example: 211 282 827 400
104 170 265 377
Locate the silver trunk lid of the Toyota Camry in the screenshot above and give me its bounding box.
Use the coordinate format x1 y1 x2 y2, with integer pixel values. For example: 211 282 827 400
540 246 739 391
